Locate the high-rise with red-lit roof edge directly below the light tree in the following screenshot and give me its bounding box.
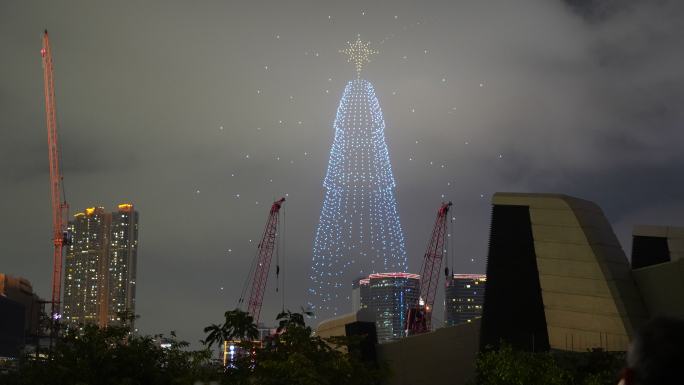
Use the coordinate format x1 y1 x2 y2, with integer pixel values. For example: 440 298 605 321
359 273 420 343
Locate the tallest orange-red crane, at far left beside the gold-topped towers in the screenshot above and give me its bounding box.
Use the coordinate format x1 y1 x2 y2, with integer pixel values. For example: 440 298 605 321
40 30 70 323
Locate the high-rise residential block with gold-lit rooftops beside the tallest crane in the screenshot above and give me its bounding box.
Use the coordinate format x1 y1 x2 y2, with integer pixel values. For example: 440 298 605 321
62 203 138 326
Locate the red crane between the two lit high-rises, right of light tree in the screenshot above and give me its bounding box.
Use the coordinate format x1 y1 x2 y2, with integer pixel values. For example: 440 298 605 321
406 202 451 335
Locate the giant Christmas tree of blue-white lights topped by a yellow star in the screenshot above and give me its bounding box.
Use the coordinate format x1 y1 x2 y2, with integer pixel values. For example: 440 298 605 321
309 38 407 318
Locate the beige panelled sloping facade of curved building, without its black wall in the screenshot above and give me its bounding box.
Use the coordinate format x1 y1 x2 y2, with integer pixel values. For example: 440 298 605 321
483 193 648 351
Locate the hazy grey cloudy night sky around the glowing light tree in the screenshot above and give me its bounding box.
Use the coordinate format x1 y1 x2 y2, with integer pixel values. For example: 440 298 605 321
0 0 684 343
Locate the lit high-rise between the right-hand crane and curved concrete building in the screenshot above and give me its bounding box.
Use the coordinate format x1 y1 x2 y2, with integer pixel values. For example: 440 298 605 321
444 274 487 326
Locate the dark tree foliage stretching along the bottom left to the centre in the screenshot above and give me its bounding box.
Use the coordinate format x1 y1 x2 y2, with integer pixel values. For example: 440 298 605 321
0 309 387 385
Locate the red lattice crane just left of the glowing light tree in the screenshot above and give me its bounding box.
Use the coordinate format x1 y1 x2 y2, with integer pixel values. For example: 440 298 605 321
247 198 285 325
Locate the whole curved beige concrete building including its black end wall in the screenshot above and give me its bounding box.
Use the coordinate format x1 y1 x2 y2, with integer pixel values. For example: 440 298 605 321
480 193 647 351
